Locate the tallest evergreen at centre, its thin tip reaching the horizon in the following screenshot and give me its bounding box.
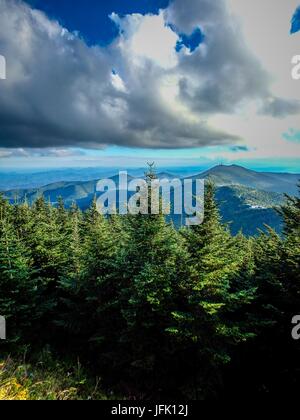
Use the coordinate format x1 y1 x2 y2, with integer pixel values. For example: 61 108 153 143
110 168 190 395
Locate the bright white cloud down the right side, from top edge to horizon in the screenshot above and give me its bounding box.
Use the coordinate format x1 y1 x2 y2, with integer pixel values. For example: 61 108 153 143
212 0 300 159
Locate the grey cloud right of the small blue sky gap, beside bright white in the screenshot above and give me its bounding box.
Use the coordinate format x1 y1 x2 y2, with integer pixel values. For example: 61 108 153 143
166 0 299 117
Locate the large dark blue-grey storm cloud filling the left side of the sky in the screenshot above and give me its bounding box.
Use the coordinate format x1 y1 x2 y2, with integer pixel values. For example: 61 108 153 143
0 0 241 148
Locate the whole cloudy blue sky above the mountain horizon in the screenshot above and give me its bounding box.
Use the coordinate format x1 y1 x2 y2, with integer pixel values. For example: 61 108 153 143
0 0 300 173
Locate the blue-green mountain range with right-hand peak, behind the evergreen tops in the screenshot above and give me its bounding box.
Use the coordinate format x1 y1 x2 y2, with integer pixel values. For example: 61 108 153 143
4 165 300 236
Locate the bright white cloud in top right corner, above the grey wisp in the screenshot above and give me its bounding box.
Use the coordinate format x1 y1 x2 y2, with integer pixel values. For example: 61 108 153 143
228 0 300 100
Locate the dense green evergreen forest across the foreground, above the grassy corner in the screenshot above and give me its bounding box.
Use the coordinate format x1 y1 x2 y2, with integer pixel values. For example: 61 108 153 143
0 175 300 400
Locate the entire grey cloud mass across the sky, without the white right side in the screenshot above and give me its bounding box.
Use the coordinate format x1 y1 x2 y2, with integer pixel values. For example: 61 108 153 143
0 0 300 154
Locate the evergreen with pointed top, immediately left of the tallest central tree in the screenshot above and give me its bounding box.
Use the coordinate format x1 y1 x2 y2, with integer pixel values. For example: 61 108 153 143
69 197 124 364
